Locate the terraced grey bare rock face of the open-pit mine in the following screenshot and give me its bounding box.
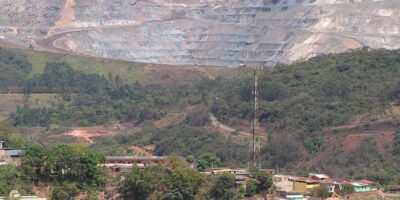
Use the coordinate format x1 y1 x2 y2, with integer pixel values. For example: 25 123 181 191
0 0 400 67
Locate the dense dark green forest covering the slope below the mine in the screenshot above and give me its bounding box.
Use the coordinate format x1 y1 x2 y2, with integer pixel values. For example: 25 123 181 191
0 48 400 191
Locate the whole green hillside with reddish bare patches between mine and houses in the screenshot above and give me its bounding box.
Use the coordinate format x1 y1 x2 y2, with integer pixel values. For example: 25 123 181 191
0 45 400 186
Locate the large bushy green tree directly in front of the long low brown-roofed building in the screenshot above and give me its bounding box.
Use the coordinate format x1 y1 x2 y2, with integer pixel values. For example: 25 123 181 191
119 166 164 200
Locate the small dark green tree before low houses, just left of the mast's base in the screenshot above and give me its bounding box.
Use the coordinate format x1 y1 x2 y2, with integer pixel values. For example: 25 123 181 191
210 173 235 200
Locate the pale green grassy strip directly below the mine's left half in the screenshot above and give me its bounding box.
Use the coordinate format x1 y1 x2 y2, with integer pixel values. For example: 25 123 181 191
0 40 237 85
